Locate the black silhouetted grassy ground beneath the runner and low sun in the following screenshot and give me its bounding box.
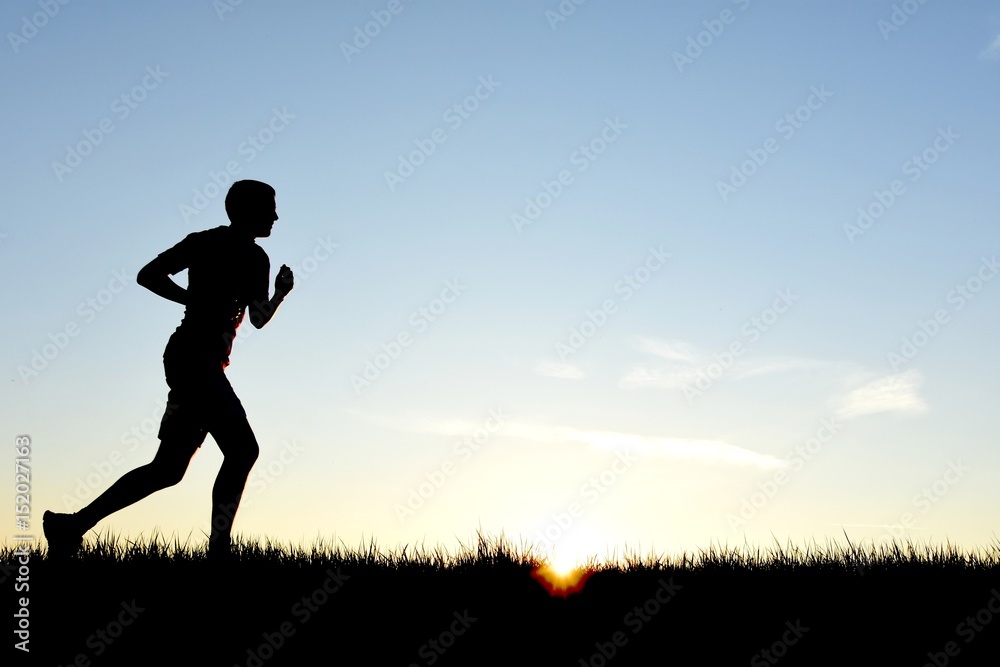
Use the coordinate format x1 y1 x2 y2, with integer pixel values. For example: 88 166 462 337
7 533 1000 667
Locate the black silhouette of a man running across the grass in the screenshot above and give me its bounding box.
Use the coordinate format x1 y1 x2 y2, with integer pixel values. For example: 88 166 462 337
42 181 294 558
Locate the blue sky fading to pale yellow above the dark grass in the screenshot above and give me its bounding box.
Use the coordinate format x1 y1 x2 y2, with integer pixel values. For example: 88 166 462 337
0 0 1000 568
